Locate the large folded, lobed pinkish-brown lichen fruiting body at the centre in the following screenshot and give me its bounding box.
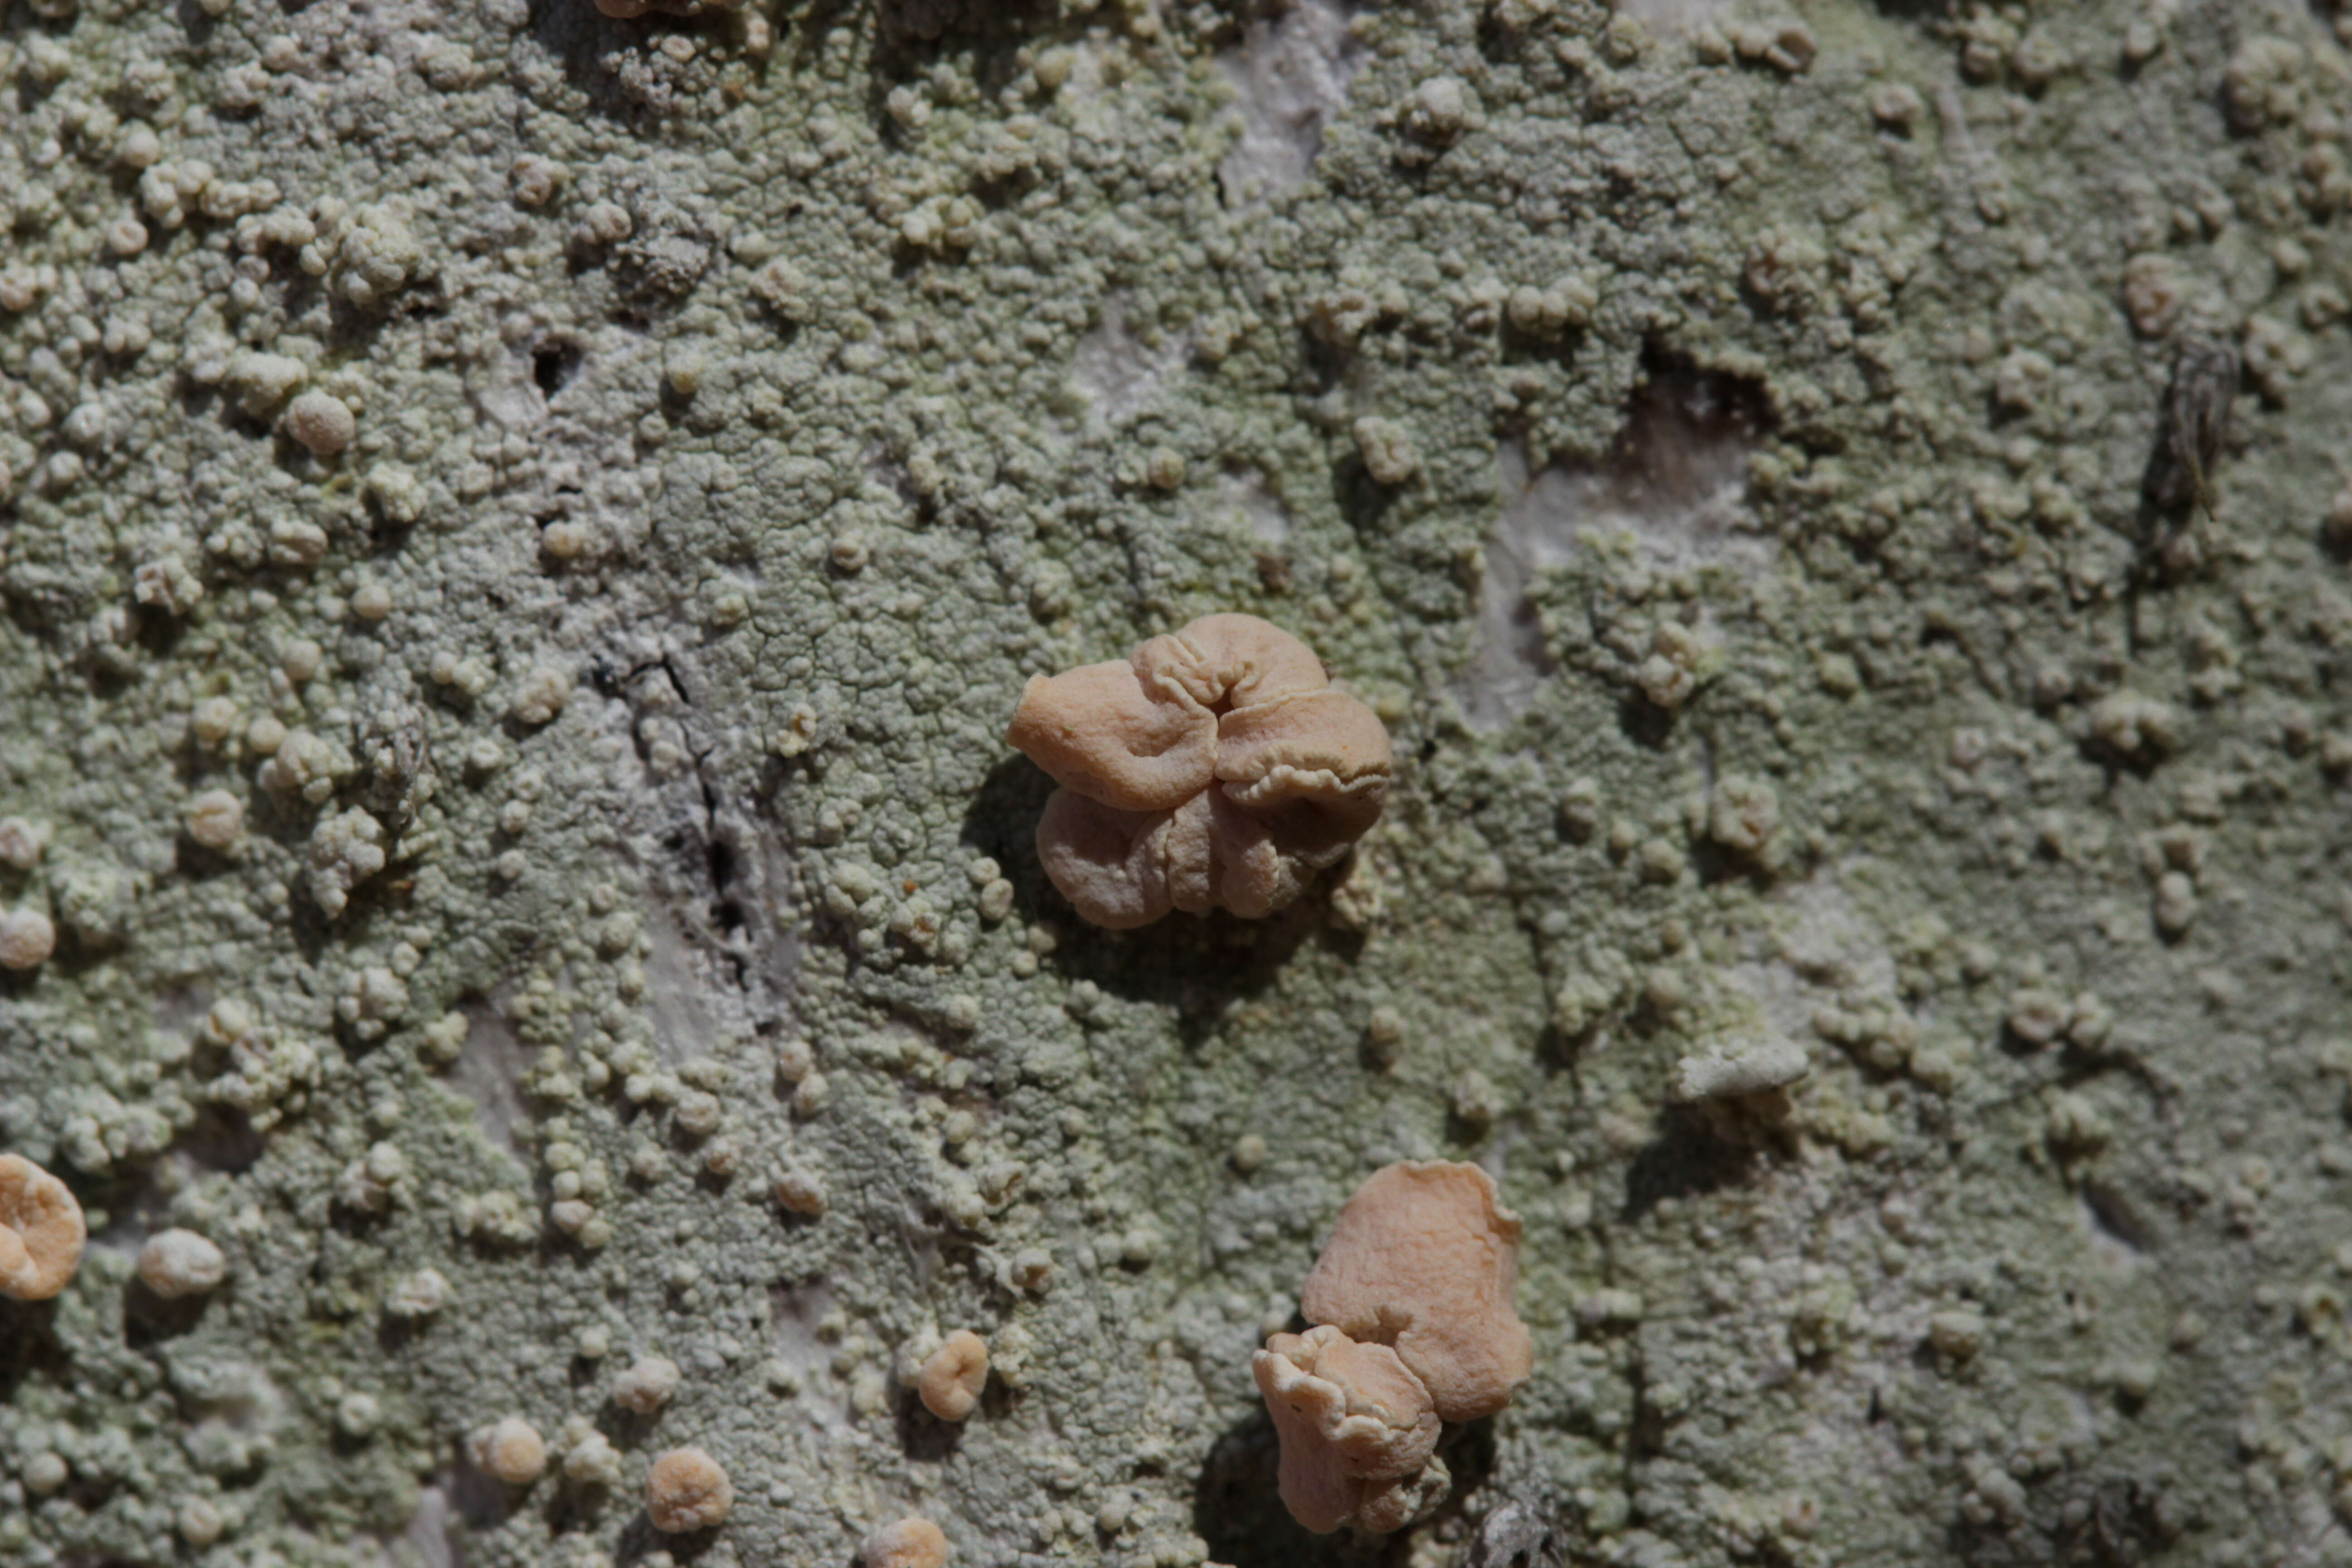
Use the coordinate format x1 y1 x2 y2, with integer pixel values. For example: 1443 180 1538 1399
1004 616 1390 931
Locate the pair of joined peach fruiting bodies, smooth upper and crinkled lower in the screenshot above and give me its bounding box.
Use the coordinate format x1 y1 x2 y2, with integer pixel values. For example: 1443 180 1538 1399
1251 1161 1536 1535
